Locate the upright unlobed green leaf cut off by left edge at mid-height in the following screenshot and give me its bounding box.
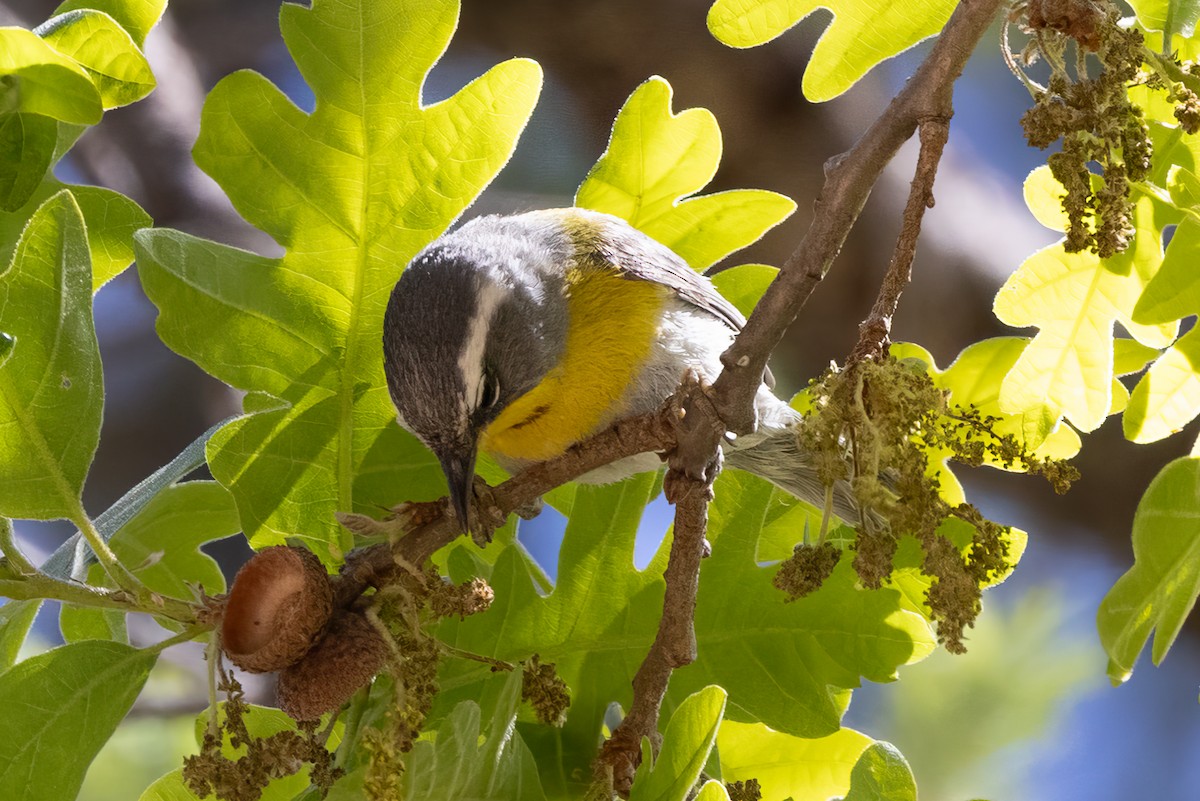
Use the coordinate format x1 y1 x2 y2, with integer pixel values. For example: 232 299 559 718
0 191 104 519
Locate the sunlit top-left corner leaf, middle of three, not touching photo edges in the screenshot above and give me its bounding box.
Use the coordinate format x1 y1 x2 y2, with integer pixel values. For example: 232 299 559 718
36 8 155 109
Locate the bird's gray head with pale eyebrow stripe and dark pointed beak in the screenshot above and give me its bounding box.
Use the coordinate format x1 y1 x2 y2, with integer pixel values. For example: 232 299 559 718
383 217 566 529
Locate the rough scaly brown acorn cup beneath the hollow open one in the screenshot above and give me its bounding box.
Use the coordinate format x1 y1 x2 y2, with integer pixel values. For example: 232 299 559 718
276 610 388 721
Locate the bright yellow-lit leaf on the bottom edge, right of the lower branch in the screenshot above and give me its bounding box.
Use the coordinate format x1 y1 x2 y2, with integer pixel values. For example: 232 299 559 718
716 721 874 801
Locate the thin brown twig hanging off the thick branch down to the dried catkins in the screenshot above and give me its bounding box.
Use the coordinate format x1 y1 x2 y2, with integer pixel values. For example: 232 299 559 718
848 115 950 365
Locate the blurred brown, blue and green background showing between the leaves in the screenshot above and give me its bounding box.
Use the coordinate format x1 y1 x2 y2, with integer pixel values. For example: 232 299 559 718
0 0 1200 801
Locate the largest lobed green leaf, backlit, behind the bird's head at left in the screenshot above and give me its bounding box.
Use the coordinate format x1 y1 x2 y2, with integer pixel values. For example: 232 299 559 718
136 0 541 561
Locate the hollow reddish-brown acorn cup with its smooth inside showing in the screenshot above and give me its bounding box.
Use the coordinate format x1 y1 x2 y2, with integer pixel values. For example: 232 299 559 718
221 546 334 673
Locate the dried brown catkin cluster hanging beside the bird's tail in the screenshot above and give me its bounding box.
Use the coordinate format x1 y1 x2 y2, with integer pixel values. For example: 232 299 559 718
774 357 1075 652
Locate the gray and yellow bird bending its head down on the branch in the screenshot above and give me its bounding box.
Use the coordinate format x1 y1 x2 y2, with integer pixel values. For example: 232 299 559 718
383 209 858 529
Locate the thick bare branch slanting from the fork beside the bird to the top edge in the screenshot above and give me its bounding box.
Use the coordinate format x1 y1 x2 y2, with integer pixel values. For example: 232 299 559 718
714 0 1002 434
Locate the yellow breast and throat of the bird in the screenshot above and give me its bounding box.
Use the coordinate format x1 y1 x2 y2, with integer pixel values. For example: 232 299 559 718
480 269 670 460
